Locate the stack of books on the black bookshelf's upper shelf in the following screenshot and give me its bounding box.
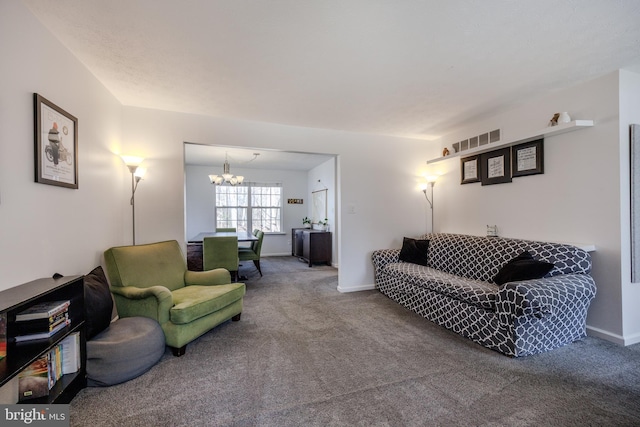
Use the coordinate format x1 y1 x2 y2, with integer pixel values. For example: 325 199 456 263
15 301 71 343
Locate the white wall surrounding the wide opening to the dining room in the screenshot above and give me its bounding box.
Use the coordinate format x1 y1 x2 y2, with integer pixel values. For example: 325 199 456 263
123 107 427 291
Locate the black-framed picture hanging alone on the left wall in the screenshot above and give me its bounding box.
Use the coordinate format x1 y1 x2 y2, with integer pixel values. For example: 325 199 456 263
33 93 78 189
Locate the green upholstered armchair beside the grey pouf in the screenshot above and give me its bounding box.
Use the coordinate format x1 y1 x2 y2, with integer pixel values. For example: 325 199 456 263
104 240 245 356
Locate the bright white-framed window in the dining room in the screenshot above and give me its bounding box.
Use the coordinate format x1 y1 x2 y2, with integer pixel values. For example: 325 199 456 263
215 182 282 233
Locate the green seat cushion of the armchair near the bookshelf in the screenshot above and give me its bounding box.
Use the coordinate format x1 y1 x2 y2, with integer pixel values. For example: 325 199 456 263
169 283 245 325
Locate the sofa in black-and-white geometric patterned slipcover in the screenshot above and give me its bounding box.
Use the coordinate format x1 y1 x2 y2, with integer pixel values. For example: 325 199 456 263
373 233 596 357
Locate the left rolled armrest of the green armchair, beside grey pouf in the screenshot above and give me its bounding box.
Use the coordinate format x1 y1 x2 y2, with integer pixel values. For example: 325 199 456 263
110 286 173 325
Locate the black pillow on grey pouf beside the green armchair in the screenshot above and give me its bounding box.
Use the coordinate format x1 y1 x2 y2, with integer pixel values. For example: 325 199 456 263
84 266 113 340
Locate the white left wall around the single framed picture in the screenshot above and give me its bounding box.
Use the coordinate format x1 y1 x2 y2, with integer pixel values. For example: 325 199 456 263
0 1 128 289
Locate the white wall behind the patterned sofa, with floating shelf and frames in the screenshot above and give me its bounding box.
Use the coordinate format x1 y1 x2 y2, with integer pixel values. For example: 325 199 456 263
432 72 640 343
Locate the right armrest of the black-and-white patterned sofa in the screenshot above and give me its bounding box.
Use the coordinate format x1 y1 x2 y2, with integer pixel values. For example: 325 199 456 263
496 274 596 324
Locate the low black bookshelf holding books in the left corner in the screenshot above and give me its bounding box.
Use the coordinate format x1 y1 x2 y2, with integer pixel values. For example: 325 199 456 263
0 276 87 404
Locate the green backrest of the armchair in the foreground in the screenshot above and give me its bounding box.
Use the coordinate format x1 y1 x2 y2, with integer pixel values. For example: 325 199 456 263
104 240 187 291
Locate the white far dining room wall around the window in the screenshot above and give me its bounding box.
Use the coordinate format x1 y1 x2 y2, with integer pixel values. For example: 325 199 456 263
186 164 309 256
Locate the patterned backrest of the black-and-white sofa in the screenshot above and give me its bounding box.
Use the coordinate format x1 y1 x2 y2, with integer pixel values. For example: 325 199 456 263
421 233 591 282
